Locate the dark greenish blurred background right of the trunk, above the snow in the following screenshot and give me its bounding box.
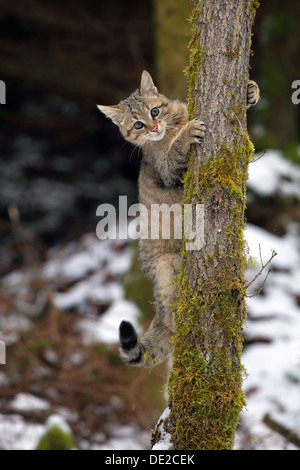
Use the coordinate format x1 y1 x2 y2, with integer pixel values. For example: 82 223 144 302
249 0 300 163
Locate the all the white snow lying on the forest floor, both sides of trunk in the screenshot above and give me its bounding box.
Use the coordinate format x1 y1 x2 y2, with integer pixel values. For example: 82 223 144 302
0 151 300 450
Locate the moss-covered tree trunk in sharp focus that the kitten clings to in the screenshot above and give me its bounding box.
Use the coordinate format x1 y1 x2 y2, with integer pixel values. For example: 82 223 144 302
164 0 258 450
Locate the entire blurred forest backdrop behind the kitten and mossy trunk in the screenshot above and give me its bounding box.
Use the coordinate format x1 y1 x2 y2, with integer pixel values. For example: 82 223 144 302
0 0 300 450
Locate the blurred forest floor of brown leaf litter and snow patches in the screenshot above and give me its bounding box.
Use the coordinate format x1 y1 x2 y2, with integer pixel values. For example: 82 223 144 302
0 151 300 450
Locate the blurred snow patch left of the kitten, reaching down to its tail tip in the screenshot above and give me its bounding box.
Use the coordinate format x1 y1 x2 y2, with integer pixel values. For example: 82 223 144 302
44 235 140 344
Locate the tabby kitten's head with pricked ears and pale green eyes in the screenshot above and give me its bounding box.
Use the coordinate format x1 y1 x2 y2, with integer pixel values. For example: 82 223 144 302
98 70 183 147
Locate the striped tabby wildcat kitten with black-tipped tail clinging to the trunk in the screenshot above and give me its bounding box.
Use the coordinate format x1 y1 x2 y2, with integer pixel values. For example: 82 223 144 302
98 71 259 367
